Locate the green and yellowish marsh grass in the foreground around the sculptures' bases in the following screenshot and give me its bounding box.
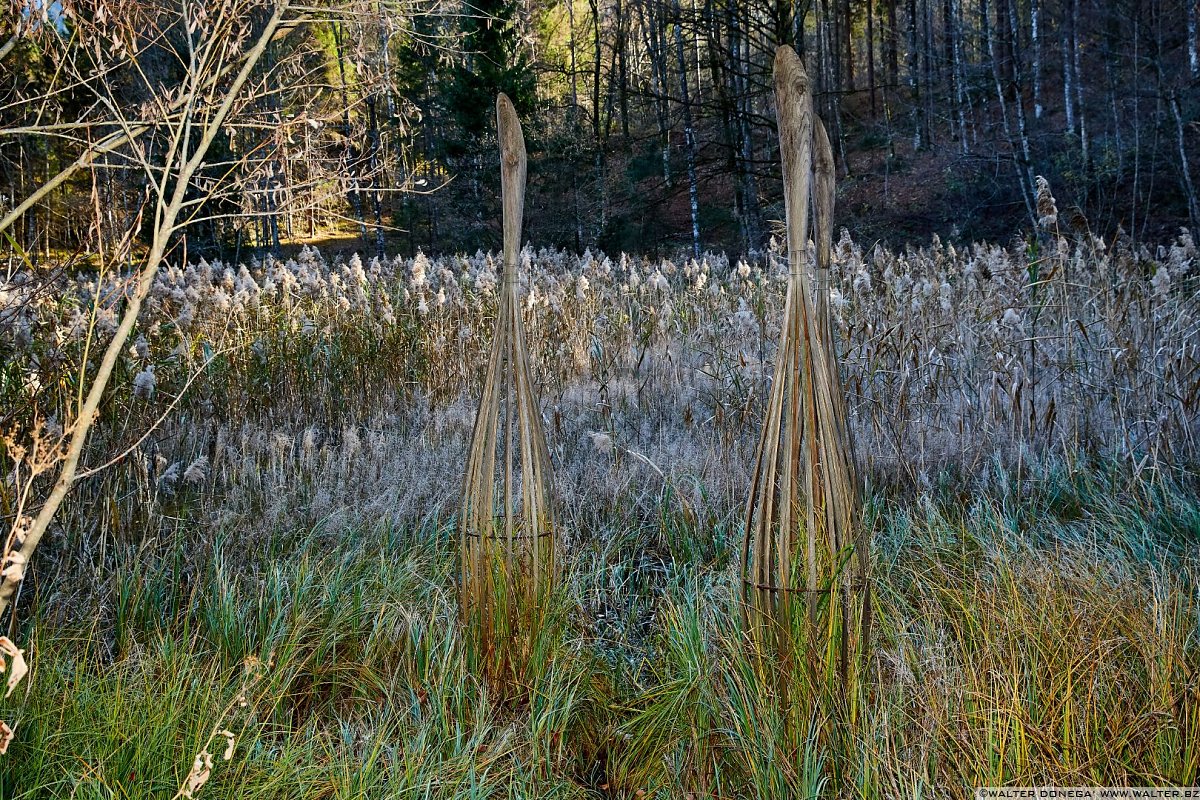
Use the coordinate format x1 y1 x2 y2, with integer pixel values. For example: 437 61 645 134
0 462 1200 799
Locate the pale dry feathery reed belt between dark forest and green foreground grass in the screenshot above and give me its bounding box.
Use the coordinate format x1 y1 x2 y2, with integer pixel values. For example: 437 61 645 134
0 227 1200 595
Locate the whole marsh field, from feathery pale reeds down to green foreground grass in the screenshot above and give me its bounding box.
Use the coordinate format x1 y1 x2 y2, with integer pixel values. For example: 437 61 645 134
0 212 1200 798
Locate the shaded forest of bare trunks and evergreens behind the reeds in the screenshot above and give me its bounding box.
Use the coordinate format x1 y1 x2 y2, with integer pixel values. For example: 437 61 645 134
0 0 1200 260
